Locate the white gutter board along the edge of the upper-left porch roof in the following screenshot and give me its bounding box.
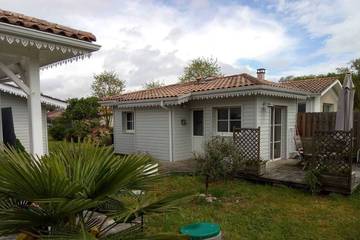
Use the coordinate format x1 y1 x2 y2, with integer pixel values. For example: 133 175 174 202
0 22 101 52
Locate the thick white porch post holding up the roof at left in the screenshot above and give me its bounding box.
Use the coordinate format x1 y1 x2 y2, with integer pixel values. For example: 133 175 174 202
25 56 44 156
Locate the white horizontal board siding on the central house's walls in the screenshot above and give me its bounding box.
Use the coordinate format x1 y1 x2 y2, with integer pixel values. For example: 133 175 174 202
114 96 297 161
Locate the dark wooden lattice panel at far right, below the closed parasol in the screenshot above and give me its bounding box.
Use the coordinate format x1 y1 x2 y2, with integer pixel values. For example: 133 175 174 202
311 131 353 176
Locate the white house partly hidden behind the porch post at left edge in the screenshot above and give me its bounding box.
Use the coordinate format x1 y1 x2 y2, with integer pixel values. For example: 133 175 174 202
0 84 67 153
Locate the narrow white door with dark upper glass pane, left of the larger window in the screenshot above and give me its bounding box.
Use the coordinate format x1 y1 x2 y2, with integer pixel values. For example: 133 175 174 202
192 110 204 153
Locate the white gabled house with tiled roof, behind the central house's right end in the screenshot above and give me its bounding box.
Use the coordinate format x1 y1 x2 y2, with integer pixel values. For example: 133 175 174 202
281 77 341 112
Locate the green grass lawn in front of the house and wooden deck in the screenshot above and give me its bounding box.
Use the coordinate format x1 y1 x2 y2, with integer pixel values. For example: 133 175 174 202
145 176 360 240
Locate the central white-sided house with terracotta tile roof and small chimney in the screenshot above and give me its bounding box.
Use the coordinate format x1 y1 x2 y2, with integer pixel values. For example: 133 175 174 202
102 69 312 161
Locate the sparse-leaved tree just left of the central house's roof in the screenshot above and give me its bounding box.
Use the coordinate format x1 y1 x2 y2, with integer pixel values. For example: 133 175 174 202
91 71 125 128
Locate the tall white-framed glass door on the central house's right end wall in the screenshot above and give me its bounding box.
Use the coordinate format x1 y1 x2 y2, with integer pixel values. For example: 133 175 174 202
270 106 283 160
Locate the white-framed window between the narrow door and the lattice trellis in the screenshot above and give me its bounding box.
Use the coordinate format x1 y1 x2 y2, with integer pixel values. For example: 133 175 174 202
217 107 241 132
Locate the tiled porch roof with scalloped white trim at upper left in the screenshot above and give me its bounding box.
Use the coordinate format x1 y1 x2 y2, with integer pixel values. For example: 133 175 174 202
0 9 100 73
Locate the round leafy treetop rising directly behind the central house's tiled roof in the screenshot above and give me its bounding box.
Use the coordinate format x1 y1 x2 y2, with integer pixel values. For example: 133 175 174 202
179 57 223 82
